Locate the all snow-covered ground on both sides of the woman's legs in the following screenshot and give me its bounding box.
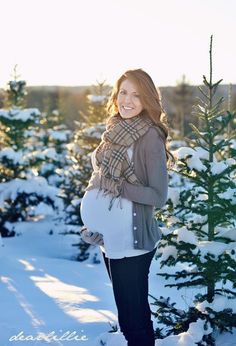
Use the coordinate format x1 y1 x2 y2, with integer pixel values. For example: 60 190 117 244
0 220 236 346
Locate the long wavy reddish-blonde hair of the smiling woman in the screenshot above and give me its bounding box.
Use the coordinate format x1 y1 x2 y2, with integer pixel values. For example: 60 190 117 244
107 69 173 161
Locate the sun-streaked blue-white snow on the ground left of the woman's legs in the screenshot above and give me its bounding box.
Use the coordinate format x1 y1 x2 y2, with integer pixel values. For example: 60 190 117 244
0 220 117 346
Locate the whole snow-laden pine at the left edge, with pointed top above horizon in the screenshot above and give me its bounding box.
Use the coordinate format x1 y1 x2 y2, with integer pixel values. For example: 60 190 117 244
0 69 63 236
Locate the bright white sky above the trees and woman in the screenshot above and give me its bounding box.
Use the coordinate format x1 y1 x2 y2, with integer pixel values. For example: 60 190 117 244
0 0 236 86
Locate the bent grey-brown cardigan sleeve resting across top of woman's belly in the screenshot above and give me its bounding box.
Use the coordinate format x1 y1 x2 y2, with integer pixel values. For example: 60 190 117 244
121 128 168 208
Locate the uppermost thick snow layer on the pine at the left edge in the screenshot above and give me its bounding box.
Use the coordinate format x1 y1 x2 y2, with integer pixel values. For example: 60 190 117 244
0 108 40 122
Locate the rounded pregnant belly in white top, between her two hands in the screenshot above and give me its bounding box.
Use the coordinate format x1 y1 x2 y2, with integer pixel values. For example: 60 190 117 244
80 189 132 235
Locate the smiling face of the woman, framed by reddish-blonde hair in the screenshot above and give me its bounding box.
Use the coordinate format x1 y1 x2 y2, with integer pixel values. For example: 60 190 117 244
116 79 143 119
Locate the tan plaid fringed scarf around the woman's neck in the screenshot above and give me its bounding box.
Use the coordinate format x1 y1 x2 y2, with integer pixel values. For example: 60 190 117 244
86 114 153 197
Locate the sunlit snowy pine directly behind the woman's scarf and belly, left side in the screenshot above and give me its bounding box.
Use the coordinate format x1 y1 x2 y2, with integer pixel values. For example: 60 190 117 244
63 81 108 261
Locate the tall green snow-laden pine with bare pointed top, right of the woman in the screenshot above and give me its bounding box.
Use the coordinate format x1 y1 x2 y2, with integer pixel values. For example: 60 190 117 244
154 37 236 345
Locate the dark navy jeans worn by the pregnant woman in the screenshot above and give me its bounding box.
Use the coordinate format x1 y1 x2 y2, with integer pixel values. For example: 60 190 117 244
103 249 156 346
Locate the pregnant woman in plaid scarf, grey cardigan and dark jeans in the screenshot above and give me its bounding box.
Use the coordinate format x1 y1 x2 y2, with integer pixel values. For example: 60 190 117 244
81 69 171 346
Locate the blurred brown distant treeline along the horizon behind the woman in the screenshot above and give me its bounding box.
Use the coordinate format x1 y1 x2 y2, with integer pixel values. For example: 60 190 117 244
0 82 236 137
